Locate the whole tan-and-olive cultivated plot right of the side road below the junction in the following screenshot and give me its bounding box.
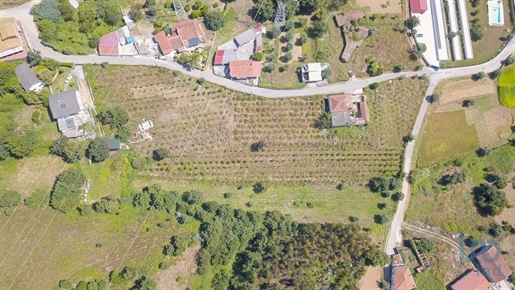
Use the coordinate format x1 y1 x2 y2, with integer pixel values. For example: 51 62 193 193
417 78 515 166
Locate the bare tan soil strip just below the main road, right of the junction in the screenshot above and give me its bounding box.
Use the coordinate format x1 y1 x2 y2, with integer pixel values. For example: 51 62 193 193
440 79 497 104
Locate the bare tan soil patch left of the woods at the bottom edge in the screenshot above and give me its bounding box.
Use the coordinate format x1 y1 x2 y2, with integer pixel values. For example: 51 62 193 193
156 246 200 290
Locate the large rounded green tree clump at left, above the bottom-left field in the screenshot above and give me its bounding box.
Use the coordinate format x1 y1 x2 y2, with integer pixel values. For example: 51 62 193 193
50 168 86 213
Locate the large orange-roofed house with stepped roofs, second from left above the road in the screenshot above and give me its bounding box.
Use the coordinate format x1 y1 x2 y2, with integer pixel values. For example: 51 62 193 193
154 19 203 55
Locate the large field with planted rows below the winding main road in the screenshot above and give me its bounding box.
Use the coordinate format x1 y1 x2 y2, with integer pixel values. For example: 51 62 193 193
86 65 427 188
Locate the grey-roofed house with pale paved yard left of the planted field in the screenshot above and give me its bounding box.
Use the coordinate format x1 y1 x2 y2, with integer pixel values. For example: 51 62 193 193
49 89 94 138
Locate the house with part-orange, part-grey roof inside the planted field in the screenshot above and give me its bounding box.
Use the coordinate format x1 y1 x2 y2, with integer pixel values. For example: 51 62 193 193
328 95 370 127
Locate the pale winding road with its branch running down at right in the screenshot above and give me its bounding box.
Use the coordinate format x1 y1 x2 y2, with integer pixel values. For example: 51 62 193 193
0 0 515 255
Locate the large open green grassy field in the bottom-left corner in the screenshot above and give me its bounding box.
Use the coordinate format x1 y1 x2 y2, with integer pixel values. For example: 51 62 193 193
0 204 190 289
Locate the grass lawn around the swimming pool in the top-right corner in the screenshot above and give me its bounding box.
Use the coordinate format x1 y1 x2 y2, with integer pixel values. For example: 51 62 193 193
445 1 512 68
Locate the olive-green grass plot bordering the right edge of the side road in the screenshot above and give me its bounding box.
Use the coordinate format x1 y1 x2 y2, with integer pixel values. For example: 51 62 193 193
418 111 479 167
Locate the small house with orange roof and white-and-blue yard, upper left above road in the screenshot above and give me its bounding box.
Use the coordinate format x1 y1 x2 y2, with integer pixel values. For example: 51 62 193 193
98 26 138 56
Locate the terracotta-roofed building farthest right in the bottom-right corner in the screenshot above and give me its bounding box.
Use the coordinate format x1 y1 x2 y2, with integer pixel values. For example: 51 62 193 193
475 246 512 283
